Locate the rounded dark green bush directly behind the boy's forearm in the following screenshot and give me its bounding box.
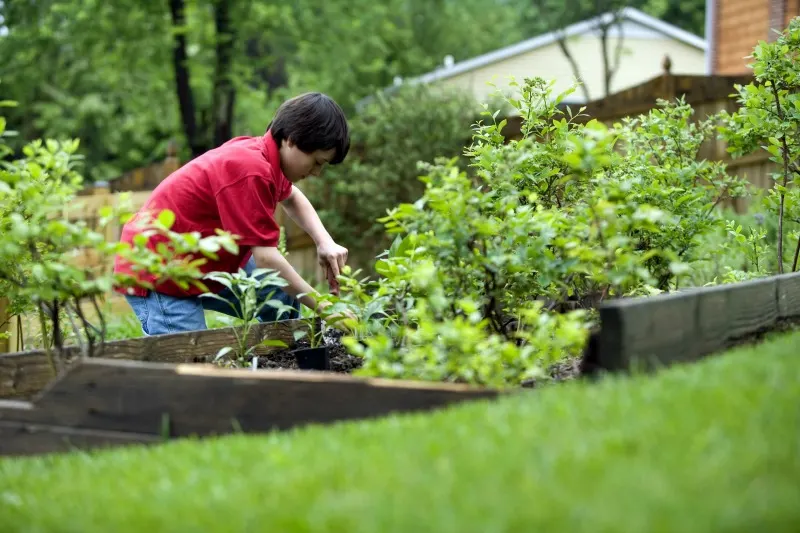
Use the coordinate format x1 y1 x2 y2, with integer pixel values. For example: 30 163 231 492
303 86 480 268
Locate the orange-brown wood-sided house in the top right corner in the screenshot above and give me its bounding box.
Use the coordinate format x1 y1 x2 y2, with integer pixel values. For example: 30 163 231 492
706 0 800 76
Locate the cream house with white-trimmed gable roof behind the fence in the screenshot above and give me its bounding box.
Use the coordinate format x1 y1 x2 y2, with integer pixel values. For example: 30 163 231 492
362 8 706 108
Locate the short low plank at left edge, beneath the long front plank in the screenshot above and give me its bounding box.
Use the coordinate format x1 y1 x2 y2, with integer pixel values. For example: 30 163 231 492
0 420 162 456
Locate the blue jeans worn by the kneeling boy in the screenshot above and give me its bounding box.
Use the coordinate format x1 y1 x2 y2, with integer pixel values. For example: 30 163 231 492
125 257 300 335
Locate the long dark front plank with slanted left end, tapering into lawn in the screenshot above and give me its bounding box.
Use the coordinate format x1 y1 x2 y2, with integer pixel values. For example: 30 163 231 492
0 359 499 437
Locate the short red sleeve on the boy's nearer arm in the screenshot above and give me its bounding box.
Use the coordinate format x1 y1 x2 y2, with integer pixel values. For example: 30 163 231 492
217 176 282 246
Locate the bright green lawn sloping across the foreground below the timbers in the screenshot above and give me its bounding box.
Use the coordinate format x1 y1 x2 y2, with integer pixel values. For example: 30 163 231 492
0 333 800 533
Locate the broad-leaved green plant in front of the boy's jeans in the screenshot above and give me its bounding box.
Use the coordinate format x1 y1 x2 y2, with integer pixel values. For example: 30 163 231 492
201 268 292 367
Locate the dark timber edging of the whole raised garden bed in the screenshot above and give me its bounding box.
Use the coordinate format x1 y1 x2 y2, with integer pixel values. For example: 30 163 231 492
0 273 800 454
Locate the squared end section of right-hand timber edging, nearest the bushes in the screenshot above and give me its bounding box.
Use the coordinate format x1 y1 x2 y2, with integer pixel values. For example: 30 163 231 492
597 291 698 371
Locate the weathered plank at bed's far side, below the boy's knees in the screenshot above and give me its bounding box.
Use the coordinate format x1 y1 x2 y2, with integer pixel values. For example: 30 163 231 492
0 320 305 398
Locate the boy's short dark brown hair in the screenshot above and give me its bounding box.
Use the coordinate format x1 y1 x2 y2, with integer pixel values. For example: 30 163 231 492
267 92 350 165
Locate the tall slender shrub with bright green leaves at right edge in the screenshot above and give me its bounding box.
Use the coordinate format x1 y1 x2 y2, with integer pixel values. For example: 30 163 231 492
720 18 800 273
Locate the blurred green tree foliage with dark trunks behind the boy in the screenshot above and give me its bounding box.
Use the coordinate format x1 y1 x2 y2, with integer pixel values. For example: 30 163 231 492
0 0 521 181
